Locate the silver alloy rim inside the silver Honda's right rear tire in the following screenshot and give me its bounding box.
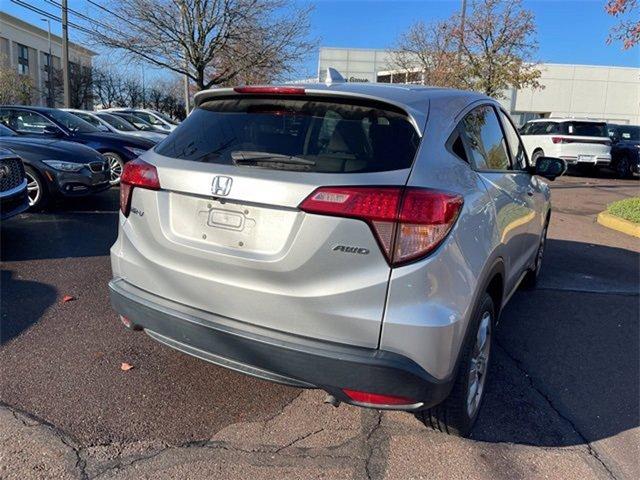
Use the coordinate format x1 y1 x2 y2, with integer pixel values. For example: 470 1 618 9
467 311 492 418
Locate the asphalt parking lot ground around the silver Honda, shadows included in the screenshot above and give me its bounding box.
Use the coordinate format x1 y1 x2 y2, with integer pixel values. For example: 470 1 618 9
0 171 640 479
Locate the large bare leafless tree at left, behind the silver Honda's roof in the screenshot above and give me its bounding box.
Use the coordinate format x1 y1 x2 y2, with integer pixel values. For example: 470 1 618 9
88 0 314 90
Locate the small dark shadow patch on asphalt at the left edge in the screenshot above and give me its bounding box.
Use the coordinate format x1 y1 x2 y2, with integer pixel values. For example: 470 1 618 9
0 270 57 345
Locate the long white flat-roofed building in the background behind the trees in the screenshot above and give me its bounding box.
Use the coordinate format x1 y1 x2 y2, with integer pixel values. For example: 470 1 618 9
318 47 640 125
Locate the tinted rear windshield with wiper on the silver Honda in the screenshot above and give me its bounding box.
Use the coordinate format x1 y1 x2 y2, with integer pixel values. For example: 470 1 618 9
156 97 420 173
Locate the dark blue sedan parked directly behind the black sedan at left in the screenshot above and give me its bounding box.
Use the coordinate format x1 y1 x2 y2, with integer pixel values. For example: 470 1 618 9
0 106 154 185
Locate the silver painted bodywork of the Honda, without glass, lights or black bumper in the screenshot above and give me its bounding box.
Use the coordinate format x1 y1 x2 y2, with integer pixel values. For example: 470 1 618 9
111 84 549 379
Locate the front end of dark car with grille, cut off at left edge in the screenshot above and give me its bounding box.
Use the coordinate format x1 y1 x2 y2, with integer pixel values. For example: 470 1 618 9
0 147 29 220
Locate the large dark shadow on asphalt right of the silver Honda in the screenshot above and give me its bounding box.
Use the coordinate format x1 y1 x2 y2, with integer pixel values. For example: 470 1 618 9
474 240 640 447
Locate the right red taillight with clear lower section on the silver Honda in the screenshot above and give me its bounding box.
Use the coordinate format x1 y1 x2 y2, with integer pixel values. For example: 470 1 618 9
300 187 463 266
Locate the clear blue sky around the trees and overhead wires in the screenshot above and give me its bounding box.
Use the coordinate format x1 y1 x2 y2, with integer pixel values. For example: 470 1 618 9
0 0 640 78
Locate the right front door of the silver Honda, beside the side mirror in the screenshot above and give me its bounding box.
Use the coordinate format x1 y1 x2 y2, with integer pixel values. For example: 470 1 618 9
499 110 547 266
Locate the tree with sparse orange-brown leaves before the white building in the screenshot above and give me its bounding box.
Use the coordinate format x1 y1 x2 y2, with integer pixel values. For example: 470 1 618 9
392 0 541 97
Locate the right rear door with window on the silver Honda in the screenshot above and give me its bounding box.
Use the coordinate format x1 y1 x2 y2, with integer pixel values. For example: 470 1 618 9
461 104 535 292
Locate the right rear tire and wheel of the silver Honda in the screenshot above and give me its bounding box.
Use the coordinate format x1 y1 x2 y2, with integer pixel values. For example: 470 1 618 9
416 293 496 437
